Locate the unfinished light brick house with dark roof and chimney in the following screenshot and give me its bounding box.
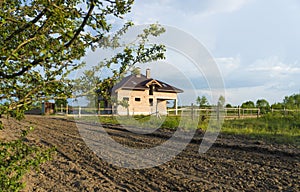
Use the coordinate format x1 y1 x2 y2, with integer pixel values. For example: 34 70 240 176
112 69 183 115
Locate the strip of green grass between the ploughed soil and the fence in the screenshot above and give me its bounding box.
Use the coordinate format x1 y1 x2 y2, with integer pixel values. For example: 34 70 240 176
74 113 300 146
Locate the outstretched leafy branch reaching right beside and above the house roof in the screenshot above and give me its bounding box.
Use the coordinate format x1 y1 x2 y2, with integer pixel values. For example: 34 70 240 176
73 24 165 104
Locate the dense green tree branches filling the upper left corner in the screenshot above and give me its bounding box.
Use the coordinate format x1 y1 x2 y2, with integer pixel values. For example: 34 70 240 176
0 0 133 118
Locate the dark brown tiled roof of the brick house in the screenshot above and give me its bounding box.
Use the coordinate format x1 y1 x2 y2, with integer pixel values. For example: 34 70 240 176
112 74 183 93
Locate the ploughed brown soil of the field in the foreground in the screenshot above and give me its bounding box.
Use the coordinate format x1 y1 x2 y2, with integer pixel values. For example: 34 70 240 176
0 116 300 191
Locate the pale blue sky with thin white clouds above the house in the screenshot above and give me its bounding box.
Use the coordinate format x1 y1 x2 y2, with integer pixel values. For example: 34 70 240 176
81 0 300 105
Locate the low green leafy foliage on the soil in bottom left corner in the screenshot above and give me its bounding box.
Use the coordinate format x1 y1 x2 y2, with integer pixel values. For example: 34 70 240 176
0 127 55 191
